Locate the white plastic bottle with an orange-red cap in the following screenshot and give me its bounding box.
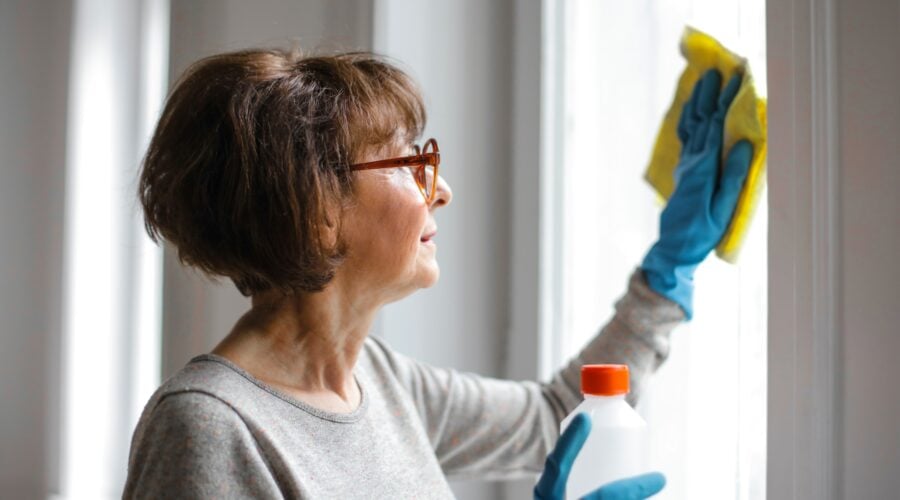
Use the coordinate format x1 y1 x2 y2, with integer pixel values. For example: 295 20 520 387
560 365 649 499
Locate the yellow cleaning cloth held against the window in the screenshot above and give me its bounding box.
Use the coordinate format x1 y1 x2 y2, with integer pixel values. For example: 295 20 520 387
644 28 766 263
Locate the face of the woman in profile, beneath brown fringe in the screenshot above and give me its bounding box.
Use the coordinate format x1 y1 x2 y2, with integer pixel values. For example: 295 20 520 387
339 142 453 302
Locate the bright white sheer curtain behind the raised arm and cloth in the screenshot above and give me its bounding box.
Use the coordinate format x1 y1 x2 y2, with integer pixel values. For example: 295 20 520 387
557 0 767 499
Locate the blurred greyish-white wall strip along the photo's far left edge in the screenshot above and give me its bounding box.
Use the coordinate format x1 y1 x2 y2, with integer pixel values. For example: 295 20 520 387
0 0 72 498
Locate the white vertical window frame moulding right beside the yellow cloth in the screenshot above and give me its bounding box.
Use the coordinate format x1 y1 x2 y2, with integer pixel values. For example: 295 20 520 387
767 0 843 500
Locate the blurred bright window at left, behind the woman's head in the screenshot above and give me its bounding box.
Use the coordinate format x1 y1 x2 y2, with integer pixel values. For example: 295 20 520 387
55 0 169 499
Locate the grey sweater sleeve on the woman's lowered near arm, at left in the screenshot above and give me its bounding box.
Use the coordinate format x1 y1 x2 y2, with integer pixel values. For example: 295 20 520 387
122 391 283 499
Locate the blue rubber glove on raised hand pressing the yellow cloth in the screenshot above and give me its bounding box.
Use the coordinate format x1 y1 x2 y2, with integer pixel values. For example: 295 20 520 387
641 70 753 320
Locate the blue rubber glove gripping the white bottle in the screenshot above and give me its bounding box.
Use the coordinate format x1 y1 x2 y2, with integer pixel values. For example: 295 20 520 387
534 413 666 500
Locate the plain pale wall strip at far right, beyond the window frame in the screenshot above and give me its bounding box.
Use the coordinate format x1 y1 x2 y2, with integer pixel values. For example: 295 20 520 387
836 0 900 499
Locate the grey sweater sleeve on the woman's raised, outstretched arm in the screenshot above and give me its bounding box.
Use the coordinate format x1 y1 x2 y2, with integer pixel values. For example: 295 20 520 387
379 270 684 479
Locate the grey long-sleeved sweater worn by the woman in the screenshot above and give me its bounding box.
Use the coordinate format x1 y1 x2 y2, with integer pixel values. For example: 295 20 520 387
123 271 683 499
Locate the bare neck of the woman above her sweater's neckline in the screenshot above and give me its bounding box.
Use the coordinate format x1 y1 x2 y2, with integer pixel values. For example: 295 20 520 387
213 286 378 413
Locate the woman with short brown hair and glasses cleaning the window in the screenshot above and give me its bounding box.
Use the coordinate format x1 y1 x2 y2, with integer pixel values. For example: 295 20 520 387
124 50 749 498
